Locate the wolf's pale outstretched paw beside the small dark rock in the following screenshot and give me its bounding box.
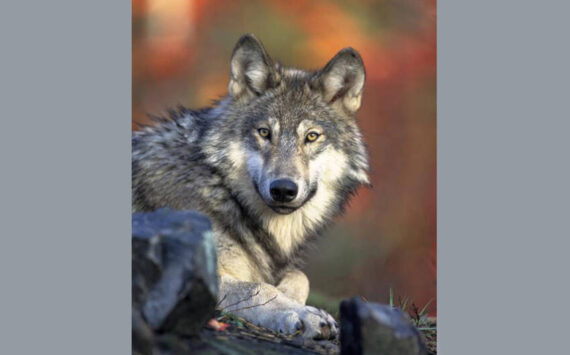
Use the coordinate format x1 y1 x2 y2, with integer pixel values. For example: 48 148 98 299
277 306 338 339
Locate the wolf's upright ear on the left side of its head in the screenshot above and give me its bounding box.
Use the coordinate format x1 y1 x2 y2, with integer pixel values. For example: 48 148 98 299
228 34 279 101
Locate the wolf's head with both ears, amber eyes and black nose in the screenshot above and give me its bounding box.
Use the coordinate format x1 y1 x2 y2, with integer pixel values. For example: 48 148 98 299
203 35 368 248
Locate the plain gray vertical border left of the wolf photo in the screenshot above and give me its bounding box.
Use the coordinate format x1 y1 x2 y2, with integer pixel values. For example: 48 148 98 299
0 0 131 354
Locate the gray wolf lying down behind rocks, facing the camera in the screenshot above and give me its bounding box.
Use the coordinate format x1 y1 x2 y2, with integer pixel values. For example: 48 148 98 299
132 34 369 339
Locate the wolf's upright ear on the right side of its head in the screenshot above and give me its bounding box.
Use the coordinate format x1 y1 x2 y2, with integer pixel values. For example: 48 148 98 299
311 48 366 114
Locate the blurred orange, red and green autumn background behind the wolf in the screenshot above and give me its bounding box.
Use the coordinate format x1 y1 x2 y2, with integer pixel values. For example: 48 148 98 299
132 0 437 315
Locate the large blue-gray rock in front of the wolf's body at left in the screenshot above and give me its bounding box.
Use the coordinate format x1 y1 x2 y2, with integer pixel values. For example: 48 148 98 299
132 208 218 338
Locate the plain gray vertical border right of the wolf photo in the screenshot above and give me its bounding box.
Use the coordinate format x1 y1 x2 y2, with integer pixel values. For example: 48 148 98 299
438 0 570 355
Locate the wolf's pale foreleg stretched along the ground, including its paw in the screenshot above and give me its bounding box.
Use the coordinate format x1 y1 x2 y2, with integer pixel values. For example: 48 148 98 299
215 276 338 339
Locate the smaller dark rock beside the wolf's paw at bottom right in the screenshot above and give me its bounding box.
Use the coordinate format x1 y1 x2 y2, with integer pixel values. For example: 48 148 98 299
340 297 425 355
